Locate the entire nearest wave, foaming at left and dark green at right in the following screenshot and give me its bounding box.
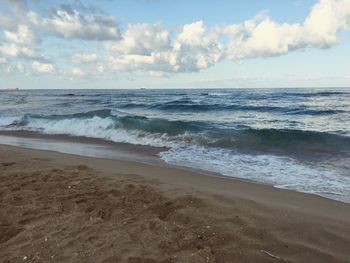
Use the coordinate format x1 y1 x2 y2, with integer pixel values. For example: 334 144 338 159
0 109 350 155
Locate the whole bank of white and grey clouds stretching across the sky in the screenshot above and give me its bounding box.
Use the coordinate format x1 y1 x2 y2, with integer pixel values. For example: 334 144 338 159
0 0 350 77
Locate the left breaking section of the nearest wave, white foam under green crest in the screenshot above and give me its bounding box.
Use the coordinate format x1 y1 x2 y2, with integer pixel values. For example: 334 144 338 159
0 109 208 147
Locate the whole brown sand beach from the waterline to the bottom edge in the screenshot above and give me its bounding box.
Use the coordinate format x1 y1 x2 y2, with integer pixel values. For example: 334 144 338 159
0 145 350 263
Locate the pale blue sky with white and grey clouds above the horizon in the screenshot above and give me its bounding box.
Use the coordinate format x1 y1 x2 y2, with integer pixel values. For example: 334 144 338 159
0 0 350 89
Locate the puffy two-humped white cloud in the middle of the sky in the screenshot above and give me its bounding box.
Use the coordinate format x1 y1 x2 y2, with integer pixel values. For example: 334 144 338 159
104 21 222 76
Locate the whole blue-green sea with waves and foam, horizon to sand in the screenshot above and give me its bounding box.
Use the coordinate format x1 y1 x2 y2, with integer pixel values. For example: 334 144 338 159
0 88 350 202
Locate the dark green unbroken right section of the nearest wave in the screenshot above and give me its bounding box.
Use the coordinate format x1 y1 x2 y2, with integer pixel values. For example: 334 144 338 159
209 128 350 155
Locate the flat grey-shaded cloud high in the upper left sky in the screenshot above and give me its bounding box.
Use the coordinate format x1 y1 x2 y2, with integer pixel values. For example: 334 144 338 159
41 10 120 40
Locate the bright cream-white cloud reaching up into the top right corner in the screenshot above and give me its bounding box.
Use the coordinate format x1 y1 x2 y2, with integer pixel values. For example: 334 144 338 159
223 0 350 60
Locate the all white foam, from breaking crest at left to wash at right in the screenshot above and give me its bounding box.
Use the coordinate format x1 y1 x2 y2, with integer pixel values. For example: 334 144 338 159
0 116 350 202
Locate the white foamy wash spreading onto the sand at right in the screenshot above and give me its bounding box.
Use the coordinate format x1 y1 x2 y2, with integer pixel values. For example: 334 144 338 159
160 146 350 202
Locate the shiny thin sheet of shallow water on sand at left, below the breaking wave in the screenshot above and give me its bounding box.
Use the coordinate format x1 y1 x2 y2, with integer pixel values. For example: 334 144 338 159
0 131 168 167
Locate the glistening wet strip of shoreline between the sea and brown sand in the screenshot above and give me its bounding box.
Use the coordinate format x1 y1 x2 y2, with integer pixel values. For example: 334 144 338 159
0 130 350 204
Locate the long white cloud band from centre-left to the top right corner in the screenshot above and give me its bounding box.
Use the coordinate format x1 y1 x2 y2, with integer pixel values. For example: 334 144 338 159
95 0 350 76
